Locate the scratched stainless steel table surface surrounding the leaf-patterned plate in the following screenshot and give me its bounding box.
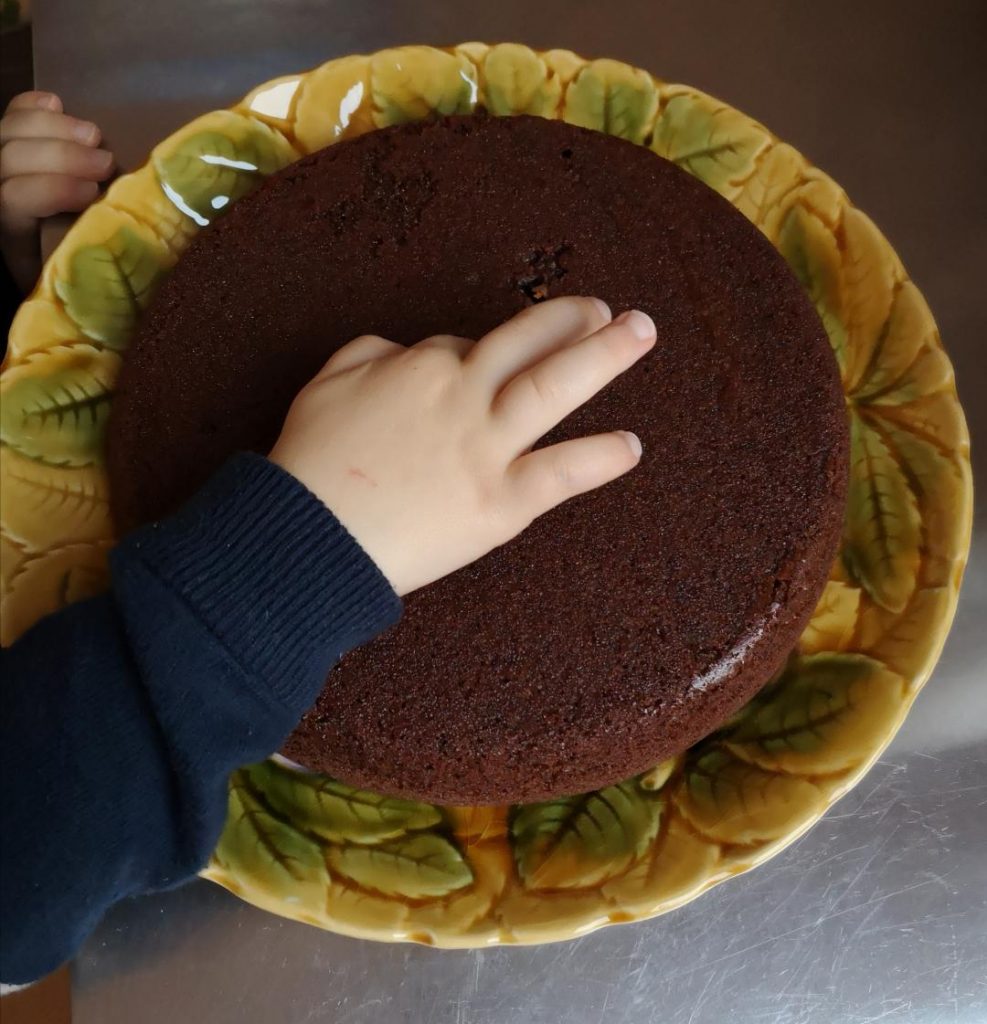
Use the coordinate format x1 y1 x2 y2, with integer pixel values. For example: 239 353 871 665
35 0 987 1024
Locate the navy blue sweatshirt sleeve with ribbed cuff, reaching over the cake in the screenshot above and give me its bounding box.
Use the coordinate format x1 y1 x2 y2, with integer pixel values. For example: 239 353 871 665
0 456 401 983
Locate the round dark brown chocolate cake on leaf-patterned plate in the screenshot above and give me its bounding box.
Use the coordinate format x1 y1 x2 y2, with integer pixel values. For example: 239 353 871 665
108 110 848 804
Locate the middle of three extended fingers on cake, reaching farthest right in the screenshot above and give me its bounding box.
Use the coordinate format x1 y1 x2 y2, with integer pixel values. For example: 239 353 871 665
494 310 655 452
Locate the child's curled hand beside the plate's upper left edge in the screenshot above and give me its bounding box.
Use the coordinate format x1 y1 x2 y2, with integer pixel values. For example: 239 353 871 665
0 92 114 291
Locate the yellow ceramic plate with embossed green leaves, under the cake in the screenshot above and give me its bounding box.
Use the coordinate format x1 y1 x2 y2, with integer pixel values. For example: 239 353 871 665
0 43 972 946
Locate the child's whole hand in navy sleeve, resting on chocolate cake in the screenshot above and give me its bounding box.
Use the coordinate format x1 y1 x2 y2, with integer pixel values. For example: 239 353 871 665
270 298 655 594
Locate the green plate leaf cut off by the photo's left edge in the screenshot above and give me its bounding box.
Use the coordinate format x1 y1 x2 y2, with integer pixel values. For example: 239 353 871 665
0 344 120 466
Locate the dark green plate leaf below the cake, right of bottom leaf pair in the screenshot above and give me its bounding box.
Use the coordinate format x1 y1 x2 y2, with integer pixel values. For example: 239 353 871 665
511 779 663 889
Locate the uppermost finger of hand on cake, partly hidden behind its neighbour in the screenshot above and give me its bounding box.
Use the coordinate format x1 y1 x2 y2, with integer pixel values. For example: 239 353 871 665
467 295 610 392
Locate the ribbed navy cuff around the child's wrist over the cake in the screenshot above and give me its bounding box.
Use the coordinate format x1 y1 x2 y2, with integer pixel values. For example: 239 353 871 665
115 455 401 714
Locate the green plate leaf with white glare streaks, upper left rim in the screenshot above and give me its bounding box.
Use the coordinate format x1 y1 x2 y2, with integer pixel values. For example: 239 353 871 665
154 118 298 227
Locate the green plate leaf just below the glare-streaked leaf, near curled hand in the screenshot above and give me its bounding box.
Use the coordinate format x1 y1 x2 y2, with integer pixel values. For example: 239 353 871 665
54 226 164 350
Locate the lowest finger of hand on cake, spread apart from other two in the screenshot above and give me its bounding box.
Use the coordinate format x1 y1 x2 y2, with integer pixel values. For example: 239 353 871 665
507 430 641 519
